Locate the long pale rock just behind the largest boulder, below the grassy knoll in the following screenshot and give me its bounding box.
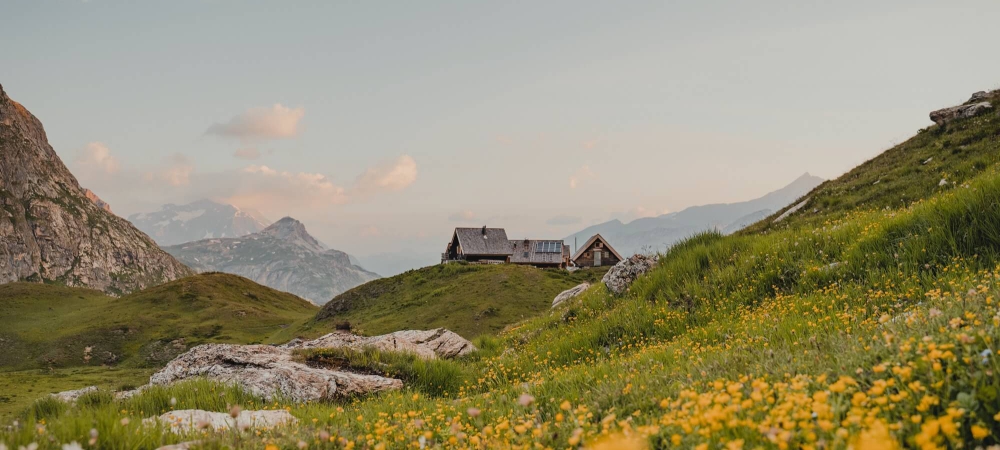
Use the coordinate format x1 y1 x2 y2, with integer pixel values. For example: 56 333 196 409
282 328 476 359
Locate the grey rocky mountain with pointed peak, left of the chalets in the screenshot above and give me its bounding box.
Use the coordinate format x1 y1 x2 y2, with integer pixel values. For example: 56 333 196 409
164 217 378 304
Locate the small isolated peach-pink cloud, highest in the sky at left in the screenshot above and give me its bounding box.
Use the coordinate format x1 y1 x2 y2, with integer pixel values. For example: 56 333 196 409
205 103 306 140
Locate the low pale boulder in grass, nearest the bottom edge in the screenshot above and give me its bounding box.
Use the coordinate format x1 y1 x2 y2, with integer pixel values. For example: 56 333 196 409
143 409 298 434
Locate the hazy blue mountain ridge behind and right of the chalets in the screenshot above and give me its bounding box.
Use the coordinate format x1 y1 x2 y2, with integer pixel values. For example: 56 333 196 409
565 173 823 255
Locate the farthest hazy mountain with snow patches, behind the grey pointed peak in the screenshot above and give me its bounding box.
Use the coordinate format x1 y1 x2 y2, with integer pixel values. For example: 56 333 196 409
128 200 270 245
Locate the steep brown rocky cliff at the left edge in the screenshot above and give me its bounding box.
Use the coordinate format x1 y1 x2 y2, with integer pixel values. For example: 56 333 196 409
0 83 192 294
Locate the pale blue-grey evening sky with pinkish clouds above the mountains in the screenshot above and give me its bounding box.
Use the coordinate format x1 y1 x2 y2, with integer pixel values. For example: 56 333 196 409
0 0 1000 262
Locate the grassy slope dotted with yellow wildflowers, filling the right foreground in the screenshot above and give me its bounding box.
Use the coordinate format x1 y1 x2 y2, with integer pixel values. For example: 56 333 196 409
0 98 1000 450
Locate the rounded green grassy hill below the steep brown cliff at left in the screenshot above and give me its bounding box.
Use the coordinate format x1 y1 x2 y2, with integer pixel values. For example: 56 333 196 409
0 273 317 370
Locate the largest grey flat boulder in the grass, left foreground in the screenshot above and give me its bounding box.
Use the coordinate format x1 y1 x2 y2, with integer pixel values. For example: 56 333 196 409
149 344 403 401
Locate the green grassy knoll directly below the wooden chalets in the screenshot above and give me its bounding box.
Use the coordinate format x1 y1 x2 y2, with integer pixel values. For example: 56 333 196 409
298 264 607 339
